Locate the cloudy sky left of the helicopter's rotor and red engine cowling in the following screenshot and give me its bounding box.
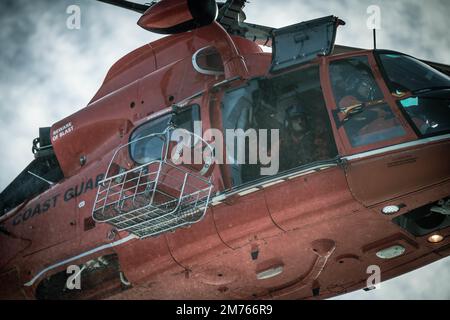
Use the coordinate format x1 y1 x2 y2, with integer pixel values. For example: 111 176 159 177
0 0 157 189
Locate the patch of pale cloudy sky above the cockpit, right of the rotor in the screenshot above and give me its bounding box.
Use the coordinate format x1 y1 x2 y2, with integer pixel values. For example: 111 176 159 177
246 0 450 64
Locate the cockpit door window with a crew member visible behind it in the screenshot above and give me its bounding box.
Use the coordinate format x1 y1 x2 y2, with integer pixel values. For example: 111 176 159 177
330 56 406 148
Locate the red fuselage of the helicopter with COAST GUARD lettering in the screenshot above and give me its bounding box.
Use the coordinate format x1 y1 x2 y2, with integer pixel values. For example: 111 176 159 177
0 1 450 299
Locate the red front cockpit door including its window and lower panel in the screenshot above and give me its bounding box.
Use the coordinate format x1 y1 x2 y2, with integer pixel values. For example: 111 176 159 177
327 54 445 206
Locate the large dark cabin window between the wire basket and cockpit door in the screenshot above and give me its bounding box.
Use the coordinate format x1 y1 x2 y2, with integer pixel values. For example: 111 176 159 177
222 65 337 186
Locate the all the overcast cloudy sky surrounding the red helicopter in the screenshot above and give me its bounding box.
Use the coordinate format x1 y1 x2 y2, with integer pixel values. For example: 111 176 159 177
0 0 450 299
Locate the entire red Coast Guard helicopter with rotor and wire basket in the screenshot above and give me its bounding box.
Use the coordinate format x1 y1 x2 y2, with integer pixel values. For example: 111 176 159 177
0 0 450 300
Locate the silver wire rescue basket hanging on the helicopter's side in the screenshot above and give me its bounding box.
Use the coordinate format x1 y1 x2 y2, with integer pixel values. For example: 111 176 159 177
92 130 212 239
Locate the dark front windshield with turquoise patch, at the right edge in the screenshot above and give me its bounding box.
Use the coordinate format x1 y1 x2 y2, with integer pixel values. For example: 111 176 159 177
378 53 450 137
